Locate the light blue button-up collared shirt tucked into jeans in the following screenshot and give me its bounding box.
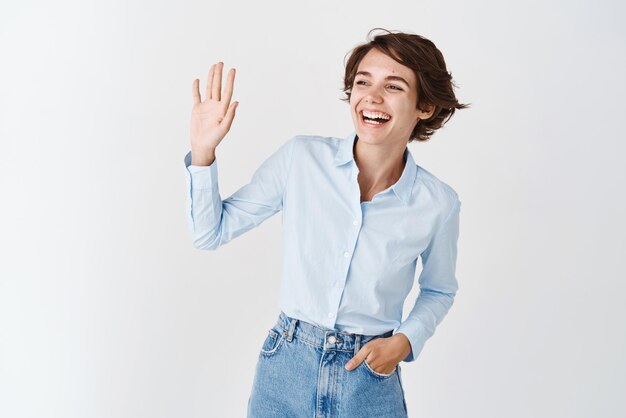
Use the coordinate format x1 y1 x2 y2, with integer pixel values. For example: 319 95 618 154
184 132 461 362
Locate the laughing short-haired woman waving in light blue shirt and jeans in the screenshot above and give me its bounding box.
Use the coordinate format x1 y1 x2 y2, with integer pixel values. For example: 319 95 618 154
185 27 467 418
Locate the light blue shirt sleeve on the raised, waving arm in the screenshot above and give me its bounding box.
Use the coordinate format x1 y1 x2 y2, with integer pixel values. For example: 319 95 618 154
184 137 296 250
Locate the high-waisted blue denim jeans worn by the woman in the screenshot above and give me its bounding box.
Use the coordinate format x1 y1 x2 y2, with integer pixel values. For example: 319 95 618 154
248 311 407 418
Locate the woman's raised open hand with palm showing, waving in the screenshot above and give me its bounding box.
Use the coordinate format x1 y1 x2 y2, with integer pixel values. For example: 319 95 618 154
191 61 239 165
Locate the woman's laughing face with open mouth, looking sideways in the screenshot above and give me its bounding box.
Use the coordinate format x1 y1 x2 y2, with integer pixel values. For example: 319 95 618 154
350 48 432 148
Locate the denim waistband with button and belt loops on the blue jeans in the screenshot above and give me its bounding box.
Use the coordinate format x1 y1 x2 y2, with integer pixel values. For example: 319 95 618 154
276 311 393 353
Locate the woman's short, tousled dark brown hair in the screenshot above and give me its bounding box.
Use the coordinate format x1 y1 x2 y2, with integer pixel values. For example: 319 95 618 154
341 28 469 142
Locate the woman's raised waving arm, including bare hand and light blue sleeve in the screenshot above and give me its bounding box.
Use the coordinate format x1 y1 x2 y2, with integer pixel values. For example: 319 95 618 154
185 63 296 250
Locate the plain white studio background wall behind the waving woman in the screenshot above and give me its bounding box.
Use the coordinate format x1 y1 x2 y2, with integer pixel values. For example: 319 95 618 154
0 1 626 418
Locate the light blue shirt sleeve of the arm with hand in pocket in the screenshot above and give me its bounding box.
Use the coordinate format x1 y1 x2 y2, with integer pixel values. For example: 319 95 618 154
394 197 461 362
